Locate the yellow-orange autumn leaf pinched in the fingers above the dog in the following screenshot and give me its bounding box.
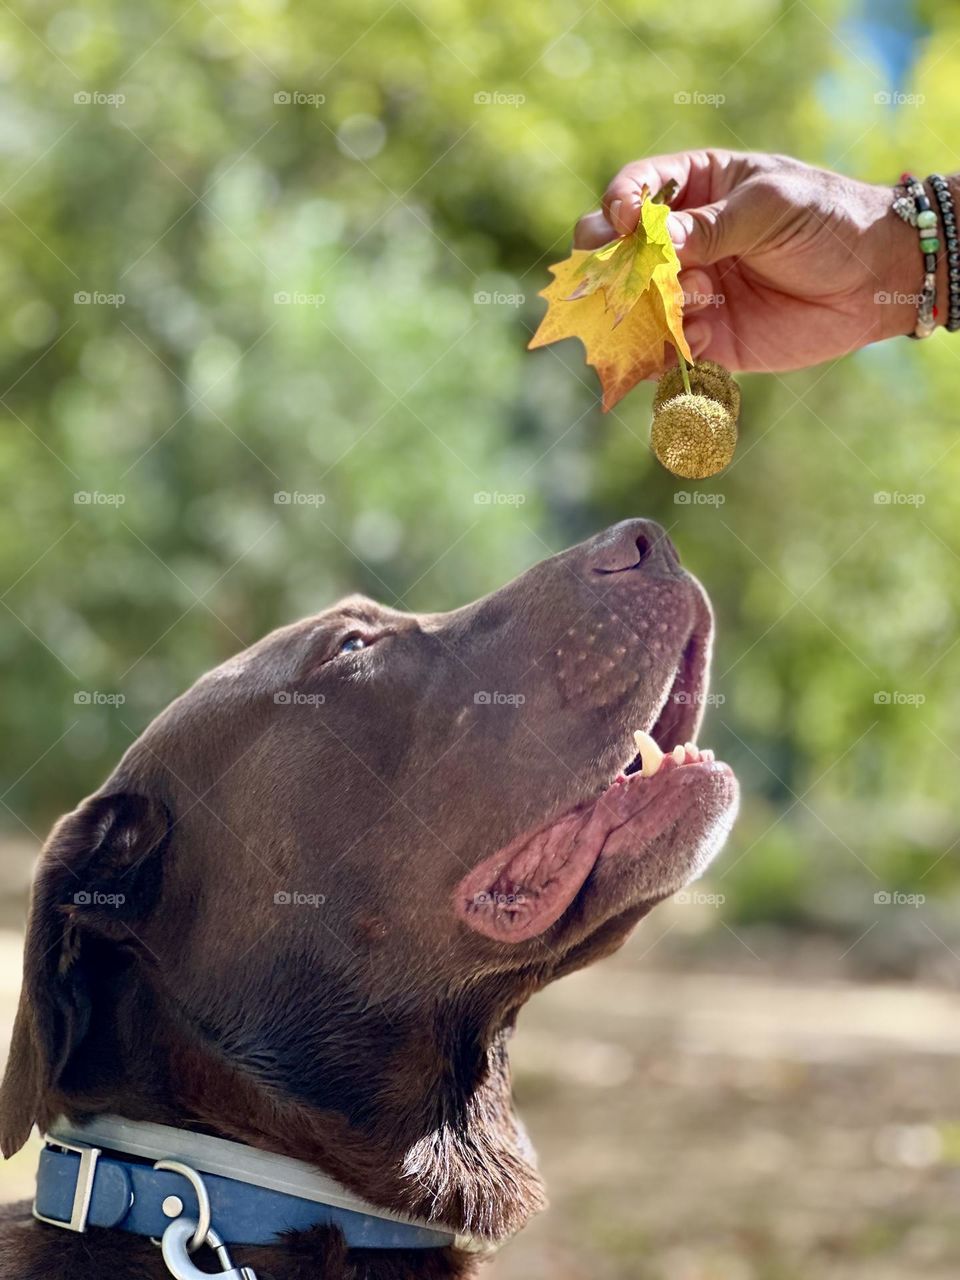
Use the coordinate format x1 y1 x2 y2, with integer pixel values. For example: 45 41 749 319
529 200 692 412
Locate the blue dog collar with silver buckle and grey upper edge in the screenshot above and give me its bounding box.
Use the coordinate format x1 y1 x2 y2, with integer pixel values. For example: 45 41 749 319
33 1116 494 1259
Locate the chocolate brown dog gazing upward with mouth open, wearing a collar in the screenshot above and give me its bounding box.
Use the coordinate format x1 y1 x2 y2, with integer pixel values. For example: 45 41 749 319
0 520 737 1280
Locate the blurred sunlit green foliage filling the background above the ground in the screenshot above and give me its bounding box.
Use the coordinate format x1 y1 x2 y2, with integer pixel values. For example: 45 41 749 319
0 0 960 927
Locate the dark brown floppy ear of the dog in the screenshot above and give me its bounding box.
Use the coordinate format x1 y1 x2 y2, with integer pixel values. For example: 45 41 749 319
0 794 172 1156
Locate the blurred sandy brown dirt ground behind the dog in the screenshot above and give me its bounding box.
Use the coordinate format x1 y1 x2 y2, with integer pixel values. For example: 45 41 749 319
0 844 960 1280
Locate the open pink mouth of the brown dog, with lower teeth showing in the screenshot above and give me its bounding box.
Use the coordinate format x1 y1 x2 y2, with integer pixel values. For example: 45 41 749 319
456 614 737 942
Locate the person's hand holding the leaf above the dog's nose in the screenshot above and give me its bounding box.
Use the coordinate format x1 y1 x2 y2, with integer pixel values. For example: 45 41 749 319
573 150 926 371
